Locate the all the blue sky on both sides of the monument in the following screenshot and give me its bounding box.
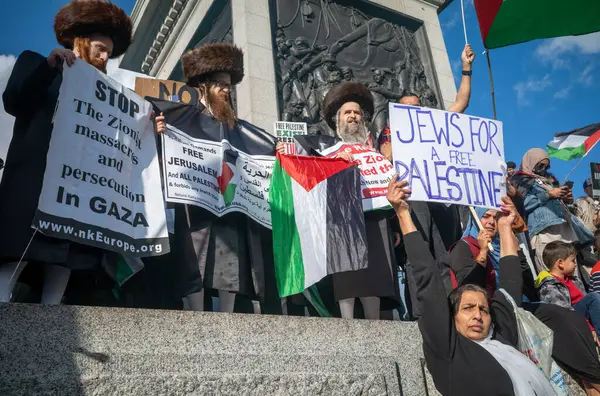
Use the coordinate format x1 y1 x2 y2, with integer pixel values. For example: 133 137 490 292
0 0 600 196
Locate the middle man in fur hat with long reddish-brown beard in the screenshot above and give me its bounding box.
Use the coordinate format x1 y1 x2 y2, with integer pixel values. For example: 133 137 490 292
153 43 280 312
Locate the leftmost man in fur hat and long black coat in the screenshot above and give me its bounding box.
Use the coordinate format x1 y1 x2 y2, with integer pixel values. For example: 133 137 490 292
0 0 132 304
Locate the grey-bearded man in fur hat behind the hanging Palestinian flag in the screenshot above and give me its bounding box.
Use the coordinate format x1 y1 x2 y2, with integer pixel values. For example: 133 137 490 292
277 81 399 319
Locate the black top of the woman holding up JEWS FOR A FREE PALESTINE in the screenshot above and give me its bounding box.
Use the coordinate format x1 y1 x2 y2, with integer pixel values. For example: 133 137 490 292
405 232 522 396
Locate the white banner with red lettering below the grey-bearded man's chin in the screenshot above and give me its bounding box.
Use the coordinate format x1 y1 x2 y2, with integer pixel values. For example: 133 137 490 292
320 142 394 211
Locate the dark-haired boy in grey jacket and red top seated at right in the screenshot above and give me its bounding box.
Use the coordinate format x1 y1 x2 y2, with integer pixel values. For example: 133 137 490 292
535 241 600 337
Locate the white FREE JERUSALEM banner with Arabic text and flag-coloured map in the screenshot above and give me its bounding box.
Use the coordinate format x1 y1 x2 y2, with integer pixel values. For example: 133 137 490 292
162 124 275 228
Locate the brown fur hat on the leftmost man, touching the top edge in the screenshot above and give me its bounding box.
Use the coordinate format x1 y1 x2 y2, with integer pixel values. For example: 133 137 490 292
54 0 133 58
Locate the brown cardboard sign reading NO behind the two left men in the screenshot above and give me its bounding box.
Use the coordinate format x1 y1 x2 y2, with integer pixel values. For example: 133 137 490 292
135 77 200 105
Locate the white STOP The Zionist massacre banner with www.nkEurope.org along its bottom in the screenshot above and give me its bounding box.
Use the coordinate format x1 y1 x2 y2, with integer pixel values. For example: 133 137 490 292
32 60 169 257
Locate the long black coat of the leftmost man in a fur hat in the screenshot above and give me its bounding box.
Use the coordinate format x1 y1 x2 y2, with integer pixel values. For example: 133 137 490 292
0 51 103 268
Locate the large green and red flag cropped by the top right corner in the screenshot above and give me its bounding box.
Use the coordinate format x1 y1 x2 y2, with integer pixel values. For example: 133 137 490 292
475 0 600 49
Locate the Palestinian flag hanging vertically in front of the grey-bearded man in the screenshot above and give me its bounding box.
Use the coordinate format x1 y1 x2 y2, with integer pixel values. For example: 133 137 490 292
269 155 367 297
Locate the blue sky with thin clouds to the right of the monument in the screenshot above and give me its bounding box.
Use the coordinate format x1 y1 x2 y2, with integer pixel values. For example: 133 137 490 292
440 0 600 196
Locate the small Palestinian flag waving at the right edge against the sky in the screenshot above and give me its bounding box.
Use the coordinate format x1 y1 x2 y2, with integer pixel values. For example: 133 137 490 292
546 122 600 161
